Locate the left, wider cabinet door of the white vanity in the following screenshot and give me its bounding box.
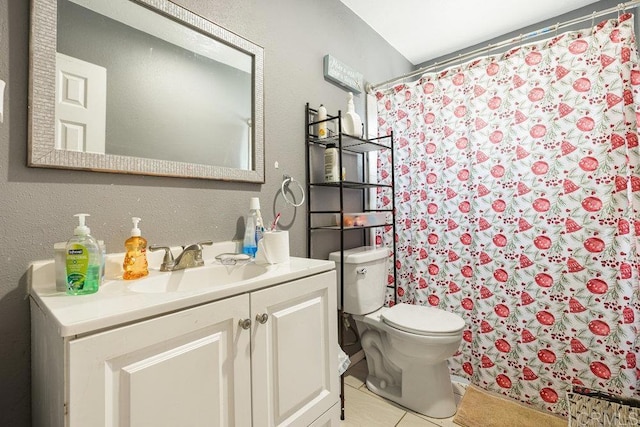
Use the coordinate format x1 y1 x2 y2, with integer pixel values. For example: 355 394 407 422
68 295 251 427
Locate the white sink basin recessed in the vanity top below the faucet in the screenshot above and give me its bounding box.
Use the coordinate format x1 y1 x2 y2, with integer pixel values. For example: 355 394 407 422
122 262 267 293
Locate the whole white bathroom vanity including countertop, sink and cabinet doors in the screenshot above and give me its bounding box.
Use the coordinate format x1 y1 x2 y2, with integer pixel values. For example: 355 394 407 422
30 251 340 427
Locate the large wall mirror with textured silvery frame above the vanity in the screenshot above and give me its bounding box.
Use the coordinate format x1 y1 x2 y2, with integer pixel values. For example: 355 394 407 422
28 0 264 183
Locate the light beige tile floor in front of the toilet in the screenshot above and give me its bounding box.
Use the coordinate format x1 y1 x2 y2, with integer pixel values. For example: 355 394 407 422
340 360 466 427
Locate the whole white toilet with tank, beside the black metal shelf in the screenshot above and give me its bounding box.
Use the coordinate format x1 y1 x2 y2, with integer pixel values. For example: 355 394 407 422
329 246 465 418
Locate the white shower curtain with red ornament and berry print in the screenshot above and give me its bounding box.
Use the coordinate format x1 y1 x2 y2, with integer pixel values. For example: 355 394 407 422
376 14 640 414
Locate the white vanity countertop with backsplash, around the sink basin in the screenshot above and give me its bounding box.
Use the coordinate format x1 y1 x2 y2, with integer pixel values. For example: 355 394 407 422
30 244 335 337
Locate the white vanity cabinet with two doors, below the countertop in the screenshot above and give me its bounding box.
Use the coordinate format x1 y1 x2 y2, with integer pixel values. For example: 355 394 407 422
31 260 340 427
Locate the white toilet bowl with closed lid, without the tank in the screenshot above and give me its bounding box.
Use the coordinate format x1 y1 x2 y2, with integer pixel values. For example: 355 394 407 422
353 303 465 418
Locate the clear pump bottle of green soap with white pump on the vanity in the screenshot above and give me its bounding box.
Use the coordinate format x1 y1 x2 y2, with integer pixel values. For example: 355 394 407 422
65 214 102 295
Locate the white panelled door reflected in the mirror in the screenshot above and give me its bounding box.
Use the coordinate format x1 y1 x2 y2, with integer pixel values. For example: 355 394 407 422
55 53 107 154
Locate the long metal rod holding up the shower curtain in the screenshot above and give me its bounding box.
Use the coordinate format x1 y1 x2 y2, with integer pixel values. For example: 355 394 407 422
367 0 640 93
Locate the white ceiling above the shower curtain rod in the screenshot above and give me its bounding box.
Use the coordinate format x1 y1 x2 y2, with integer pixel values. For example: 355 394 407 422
341 0 595 65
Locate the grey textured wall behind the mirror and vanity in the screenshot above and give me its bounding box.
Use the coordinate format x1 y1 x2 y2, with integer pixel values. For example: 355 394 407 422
0 0 411 427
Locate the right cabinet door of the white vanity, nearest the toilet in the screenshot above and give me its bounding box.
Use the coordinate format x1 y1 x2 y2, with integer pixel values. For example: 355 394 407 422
251 271 339 426
